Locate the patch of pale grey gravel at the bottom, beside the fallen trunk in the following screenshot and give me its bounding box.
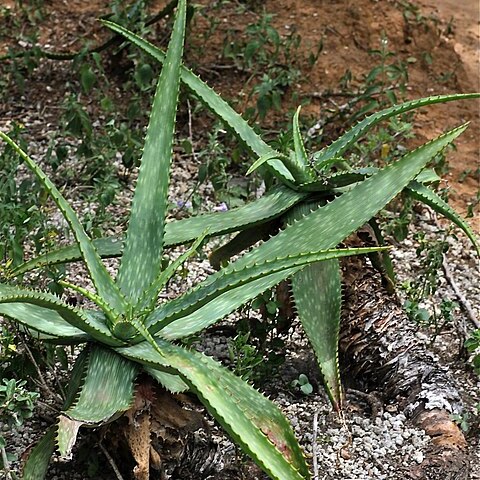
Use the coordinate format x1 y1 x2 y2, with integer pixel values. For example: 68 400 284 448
277 395 430 480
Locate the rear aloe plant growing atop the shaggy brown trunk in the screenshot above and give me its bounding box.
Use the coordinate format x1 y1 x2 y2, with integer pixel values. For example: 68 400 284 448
11 15 480 422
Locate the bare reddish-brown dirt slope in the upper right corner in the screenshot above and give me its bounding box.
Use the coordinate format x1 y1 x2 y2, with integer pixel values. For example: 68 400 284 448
255 0 480 224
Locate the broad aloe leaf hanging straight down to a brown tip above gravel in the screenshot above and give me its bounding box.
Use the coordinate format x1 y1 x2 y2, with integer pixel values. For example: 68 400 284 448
291 260 342 411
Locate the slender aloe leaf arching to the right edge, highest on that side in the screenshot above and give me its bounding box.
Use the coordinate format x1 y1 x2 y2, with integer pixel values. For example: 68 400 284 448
313 93 480 163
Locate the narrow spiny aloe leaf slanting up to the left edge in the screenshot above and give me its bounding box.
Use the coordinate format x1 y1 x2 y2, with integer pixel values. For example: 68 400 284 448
0 132 125 313
